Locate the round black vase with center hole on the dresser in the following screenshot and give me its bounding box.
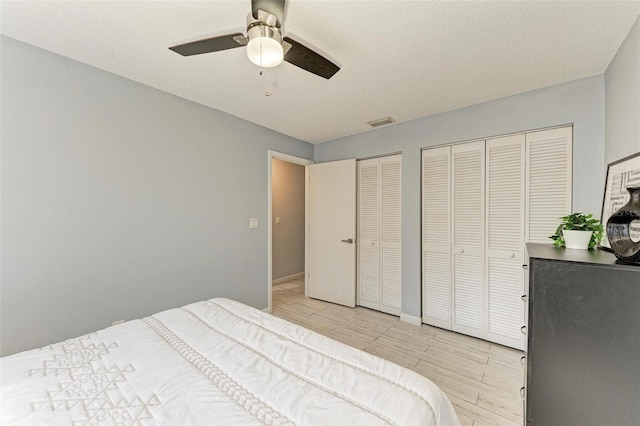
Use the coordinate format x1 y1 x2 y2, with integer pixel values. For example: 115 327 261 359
607 186 640 264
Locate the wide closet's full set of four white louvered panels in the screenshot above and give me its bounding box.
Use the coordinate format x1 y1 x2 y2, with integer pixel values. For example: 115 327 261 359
422 126 573 349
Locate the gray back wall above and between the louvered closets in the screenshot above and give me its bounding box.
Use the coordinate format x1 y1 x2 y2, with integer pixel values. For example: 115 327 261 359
315 75 605 317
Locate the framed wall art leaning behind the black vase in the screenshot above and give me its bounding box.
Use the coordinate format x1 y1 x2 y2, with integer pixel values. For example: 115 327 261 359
599 152 640 251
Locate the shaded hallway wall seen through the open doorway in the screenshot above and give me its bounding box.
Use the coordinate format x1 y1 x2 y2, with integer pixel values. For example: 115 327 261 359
271 158 305 280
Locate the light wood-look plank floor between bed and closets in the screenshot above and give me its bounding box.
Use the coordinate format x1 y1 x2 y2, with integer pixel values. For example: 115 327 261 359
273 279 524 426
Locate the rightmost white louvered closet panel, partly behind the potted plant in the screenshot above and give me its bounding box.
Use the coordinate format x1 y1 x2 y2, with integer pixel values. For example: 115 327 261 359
525 127 573 244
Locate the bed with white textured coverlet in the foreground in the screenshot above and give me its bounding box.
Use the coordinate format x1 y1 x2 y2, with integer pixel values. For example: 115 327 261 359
0 299 459 425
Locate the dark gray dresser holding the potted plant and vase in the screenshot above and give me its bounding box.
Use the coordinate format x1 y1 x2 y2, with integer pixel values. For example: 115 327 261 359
523 244 640 426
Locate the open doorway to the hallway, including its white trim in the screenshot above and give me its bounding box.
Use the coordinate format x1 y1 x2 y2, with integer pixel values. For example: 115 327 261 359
267 151 313 312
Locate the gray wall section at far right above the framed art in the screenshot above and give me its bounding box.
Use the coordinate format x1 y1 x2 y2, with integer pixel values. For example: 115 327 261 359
604 18 640 164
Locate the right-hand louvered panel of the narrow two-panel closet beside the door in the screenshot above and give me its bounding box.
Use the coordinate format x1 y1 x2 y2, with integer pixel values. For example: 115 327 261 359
380 155 402 315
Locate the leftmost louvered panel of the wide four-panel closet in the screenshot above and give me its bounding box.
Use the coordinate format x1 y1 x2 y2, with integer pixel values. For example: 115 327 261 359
422 146 451 329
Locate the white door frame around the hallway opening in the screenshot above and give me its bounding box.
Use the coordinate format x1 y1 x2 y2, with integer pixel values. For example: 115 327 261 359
265 150 315 313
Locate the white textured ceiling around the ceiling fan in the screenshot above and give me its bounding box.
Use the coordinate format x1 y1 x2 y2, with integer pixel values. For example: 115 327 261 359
0 0 640 143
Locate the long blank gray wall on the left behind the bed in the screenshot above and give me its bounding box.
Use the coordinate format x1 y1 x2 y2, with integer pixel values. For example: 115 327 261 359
0 37 313 355
